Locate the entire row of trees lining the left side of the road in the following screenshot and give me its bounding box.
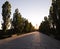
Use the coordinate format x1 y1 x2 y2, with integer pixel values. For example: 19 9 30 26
0 1 35 39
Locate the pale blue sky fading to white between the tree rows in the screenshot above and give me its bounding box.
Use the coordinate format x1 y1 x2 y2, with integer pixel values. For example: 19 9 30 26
0 0 51 28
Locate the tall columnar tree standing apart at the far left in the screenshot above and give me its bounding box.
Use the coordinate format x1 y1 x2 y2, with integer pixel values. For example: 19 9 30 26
2 1 11 32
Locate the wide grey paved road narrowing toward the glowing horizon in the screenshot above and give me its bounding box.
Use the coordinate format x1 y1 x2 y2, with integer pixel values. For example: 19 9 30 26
0 31 60 49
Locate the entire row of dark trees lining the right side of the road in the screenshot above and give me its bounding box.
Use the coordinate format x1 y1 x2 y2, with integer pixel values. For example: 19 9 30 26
39 0 60 40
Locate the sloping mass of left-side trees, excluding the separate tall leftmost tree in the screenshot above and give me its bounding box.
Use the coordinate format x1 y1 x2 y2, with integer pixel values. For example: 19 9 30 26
13 9 34 34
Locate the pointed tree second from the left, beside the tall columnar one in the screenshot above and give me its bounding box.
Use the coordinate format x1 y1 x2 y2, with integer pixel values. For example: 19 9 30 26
13 9 23 32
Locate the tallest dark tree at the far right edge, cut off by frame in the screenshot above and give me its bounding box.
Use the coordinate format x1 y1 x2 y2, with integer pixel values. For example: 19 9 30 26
49 0 60 38
